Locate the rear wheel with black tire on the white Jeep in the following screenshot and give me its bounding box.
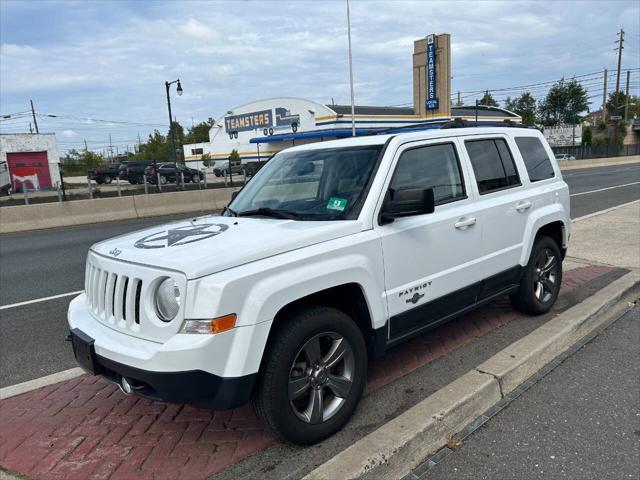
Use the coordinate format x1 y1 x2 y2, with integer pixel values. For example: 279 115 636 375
510 236 562 315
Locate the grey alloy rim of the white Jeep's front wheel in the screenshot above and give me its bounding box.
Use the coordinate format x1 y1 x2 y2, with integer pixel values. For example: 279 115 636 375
288 332 355 424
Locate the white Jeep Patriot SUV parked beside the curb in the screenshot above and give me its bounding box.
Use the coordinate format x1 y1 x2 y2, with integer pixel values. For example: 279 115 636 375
68 124 571 444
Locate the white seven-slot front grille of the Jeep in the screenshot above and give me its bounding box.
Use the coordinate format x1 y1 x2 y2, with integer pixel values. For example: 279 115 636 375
85 262 142 330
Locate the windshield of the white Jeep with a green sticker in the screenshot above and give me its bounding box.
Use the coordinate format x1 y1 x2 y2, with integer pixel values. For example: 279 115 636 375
225 145 382 220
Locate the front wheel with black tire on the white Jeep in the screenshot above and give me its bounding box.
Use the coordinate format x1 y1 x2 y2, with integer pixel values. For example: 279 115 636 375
252 306 367 445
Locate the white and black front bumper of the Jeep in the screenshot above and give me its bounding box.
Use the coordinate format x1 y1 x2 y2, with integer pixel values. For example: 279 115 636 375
68 295 271 410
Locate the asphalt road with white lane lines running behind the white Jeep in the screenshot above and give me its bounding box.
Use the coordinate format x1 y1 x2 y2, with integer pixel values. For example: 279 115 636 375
0 165 640 386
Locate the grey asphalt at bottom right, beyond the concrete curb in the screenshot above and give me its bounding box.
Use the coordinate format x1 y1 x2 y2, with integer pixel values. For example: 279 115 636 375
420 307 640 480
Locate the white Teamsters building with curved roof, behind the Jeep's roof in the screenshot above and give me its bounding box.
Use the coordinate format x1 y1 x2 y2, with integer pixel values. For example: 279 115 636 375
184 97 521 168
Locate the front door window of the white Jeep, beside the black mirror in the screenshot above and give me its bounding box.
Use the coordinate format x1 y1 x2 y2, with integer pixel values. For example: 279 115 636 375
390 143 466 205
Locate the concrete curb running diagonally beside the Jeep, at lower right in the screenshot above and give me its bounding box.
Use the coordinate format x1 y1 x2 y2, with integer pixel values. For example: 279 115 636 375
304 271 640 480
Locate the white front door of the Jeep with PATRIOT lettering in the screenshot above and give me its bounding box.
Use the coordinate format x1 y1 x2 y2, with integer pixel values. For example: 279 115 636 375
376 139 482 341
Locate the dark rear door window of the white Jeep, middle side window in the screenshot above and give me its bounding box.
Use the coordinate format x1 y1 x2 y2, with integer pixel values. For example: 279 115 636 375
464 138 520 195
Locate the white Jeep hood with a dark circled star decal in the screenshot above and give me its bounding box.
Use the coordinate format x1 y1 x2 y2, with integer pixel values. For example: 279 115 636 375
91 215 362 278
